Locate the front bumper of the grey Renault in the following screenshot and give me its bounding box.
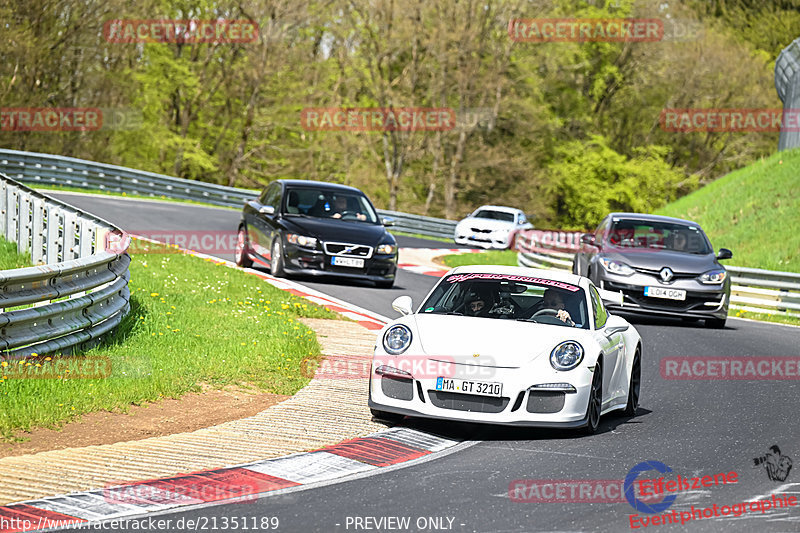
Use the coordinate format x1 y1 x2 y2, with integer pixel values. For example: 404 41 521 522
600 272 730 319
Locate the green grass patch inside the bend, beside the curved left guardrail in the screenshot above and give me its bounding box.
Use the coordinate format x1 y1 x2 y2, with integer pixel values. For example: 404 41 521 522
0 245 337 441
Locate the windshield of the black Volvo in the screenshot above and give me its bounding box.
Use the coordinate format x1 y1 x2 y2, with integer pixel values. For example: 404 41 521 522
283 187 378 224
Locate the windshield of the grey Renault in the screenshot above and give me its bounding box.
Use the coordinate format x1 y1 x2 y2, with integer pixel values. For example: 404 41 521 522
608 220 711 254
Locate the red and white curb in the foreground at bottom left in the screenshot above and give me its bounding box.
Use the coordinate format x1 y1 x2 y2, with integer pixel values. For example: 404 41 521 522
0 427 460 533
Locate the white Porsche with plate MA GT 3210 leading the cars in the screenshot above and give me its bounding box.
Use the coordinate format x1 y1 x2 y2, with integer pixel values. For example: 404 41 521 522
369 265 642 433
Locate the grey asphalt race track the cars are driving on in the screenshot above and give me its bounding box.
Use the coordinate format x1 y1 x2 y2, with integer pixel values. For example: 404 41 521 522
48 191 800 532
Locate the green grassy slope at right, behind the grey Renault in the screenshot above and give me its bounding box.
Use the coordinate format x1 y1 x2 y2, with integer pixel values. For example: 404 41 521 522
656 149 800 272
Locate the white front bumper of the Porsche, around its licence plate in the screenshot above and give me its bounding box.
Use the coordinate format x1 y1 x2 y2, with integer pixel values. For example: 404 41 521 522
369 355 596 428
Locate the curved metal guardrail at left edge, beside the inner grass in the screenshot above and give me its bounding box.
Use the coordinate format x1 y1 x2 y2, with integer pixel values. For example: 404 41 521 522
0 173 130 359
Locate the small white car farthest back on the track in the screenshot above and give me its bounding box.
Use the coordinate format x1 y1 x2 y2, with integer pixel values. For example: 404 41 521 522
453 205 533 249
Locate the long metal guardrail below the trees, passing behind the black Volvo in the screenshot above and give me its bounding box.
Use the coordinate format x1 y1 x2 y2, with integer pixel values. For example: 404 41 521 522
0 149 456 239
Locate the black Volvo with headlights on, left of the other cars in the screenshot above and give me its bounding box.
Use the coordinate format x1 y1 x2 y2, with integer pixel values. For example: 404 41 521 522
235 180 397 288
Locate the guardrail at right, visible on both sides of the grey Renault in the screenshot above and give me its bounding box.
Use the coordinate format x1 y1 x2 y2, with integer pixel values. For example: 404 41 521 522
516 230 800 316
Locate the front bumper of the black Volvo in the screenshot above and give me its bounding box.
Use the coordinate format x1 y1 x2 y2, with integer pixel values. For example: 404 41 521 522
283 243 397 281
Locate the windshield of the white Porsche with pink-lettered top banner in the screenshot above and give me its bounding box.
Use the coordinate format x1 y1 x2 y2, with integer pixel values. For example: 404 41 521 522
420 273 589 329
